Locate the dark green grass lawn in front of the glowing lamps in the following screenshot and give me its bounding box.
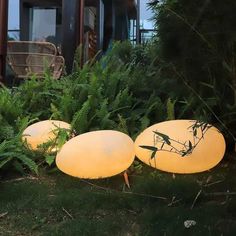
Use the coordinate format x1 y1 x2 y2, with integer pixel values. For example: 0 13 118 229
0 156 236 236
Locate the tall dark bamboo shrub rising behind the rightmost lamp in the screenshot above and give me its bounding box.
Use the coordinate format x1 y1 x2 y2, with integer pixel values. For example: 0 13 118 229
150 0 236 148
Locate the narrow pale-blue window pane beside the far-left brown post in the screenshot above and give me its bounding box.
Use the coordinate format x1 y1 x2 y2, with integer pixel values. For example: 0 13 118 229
8 0 20 40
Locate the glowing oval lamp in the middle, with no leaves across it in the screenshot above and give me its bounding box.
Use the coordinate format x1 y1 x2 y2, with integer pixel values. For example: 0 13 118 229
56 130 135 179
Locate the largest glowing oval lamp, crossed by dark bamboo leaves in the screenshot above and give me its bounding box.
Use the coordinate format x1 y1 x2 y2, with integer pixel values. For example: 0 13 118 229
135 120 226 174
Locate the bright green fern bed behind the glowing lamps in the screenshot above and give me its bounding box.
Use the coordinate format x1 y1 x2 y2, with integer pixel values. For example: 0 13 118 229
0 42 174 173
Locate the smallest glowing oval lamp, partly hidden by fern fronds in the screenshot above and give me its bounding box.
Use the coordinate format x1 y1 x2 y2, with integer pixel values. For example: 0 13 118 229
22 120 70 152
